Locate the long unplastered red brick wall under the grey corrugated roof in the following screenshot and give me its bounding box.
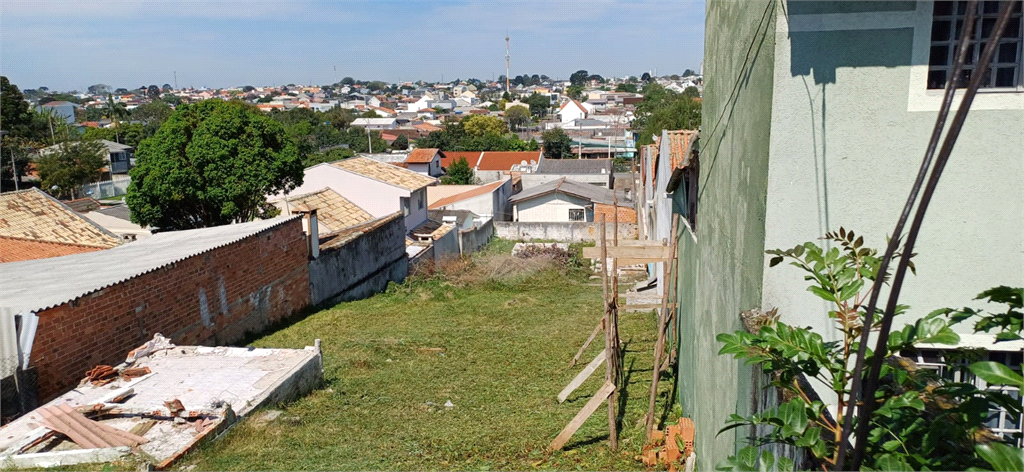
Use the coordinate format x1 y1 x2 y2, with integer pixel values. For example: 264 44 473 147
32 219 309 399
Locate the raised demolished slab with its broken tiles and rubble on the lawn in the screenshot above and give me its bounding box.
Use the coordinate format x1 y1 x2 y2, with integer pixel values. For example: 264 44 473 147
0 335 324 469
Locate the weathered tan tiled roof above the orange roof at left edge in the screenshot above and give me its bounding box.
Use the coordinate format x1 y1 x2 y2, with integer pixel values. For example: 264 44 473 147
0 188 121 251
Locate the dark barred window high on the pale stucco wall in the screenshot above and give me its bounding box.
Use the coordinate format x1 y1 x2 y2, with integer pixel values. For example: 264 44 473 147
928 0 1024 89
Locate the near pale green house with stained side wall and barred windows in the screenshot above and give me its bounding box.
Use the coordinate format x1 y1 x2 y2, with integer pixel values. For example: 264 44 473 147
679 0 1024 470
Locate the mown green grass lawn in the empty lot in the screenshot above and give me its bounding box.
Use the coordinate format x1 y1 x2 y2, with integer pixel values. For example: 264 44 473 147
177 242 671 470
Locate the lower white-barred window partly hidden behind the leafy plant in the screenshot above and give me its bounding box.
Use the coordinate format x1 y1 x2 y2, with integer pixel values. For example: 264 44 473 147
900 349 1024 447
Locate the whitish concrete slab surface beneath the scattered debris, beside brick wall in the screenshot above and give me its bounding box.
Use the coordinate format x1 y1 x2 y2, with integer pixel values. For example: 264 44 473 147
0 342 324 469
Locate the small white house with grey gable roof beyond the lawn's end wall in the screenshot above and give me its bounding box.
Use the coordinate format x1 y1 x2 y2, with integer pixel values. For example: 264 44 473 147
509 177 636 223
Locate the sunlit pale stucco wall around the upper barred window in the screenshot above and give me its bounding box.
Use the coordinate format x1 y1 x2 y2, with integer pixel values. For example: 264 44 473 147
763 2 1024 340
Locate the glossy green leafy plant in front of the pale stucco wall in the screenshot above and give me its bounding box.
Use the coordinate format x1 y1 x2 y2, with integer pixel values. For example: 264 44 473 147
718 228 1021 470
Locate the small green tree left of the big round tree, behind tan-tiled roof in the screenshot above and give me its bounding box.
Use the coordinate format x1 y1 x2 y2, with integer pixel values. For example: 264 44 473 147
36 141 110 199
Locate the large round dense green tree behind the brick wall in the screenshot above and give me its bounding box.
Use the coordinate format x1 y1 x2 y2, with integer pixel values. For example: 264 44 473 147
125 100 303 229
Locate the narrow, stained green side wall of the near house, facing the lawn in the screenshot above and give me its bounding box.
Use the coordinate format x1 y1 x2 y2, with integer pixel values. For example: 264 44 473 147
676 0 778 464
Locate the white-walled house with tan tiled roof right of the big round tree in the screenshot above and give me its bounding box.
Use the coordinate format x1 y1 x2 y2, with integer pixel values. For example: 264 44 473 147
278 157 437 230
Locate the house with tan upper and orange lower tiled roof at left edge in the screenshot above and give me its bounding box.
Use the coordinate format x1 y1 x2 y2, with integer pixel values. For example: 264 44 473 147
0 188 121 262
